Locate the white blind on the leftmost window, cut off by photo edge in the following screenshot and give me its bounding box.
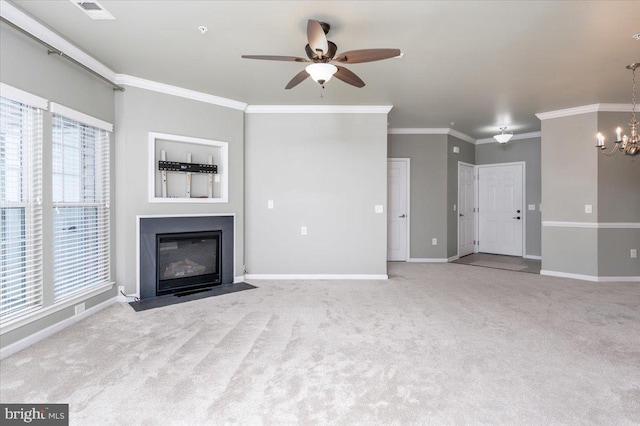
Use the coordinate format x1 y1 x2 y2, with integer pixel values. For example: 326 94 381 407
0 96 46 323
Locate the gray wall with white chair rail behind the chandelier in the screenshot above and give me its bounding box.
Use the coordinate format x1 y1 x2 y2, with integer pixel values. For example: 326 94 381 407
542 108 640 277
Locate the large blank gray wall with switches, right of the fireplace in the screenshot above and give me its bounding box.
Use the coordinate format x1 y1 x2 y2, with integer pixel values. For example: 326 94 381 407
245 114 387 274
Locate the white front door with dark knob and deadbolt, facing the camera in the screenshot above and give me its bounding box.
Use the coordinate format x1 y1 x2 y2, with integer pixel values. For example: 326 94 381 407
478 164 524 256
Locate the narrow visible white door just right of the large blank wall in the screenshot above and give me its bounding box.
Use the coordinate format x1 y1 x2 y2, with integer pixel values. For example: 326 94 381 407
387 159 409 261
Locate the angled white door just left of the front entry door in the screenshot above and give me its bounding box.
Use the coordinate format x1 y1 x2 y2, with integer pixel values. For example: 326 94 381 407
458 163 476 257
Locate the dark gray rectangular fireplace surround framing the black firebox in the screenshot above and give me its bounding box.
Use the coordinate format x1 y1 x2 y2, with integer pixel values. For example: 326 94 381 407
139 216 234 299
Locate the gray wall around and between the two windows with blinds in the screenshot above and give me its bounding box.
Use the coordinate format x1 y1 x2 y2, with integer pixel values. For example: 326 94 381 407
0 24 116 347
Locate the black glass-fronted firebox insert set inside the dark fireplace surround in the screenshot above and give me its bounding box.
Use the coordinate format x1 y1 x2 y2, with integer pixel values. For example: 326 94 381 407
156 231 222 296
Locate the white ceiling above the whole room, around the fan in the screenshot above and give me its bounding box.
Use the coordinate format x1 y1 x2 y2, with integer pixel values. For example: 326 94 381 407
5 0 640 139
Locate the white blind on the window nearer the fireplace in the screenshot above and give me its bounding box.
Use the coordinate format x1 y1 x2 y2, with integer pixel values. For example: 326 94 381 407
52 113 110 301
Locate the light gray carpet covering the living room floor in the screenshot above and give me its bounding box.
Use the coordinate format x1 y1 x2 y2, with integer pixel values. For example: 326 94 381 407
0 263 640 425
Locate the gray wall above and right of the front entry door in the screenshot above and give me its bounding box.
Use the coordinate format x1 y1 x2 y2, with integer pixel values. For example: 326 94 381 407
476 137 542 256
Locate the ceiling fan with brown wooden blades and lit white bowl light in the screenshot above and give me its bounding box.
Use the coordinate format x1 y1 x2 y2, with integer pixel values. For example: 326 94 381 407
242 19 402 89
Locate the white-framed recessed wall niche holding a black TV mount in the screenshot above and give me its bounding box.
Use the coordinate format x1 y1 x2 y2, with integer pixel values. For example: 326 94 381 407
149 132 229 203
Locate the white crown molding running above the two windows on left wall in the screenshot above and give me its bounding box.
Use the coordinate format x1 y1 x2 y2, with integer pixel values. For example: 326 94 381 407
0 0 116 81
